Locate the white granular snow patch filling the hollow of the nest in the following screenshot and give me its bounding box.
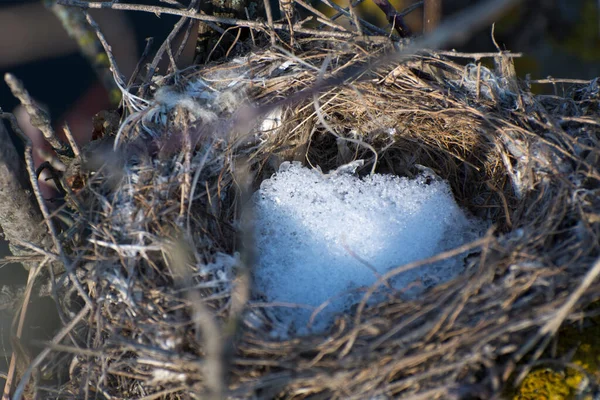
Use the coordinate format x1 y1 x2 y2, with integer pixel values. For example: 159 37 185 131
254 163 483 334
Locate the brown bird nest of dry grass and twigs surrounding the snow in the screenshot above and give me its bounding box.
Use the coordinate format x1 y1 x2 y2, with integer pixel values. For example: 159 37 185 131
10 28 600 399
